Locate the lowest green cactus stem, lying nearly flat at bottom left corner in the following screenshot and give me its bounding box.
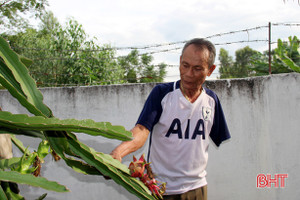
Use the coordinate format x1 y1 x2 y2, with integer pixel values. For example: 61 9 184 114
0 171 69 192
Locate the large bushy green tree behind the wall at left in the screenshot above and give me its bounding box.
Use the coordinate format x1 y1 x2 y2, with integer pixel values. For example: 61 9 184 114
4 12 124 86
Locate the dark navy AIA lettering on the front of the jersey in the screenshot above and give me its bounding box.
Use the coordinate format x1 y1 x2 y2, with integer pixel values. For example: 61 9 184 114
166 118 205 140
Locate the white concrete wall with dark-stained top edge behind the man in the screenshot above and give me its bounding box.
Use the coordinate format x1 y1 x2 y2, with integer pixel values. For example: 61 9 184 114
0 73 300 200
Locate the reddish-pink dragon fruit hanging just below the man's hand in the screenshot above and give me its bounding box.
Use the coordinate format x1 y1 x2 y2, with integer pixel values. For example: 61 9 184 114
128 154 166 199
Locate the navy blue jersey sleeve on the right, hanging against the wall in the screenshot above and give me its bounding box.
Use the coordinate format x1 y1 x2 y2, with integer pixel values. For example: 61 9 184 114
207 91 231 146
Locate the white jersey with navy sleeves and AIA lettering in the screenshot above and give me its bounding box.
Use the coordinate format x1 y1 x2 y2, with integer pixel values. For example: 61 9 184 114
137 81 230 195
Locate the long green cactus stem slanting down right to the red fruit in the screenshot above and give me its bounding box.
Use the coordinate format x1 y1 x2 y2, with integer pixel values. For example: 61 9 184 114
48 132 154 199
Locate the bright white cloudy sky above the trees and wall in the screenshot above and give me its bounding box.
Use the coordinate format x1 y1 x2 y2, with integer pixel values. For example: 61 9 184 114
48 0 300 81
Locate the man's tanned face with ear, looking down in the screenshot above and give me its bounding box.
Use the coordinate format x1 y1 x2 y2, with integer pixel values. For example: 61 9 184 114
179 45 215 90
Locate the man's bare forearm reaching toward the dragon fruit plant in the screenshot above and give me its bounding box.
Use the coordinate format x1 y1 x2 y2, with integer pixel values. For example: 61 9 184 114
110 124 149 162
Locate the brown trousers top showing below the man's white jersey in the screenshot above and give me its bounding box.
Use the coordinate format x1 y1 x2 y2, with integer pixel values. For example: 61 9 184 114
164 185 207 200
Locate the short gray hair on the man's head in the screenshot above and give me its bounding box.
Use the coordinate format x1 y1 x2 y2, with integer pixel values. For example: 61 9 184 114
181 38 216 67
